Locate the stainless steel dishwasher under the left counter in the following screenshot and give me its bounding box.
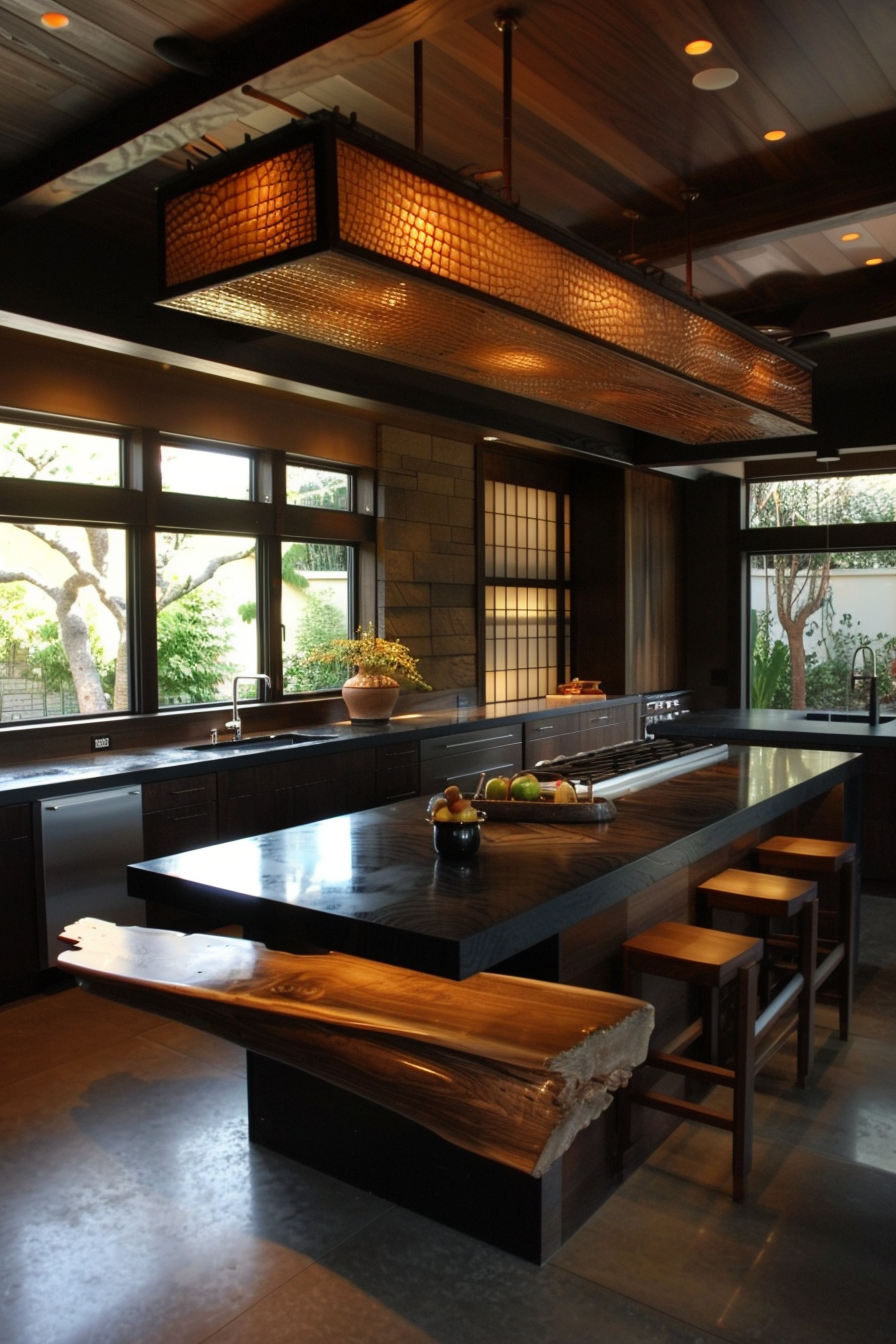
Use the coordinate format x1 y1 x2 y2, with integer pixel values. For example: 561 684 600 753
38 785 146 966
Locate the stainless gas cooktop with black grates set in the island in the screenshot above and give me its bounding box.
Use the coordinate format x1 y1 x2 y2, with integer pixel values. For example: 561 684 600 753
535 738 728 798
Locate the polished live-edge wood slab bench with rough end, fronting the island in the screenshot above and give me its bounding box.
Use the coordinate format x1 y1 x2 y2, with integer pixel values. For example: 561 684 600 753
59 918 653 1176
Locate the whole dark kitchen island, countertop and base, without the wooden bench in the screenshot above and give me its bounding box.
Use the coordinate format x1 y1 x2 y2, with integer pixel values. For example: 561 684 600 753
129 747 861 1262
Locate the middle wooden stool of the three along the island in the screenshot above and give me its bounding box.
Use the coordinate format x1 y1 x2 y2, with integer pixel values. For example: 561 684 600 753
697 868 818 1087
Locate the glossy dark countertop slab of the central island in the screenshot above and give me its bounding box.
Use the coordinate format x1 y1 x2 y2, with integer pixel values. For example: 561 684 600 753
129 746 861 978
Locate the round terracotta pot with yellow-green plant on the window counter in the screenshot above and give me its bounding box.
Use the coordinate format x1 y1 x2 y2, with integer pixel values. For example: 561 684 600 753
305 621 433 723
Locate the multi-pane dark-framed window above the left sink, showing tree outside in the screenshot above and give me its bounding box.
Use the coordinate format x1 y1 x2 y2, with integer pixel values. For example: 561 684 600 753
0 417 375 723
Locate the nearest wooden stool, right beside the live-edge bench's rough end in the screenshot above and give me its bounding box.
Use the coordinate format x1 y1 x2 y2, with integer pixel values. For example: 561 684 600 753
617 923 762 1203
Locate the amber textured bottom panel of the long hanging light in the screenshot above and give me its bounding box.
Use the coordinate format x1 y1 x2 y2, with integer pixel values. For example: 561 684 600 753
167 253 810 444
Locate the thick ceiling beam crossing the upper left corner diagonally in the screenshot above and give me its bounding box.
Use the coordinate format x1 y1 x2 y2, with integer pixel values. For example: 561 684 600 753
0 0 472 208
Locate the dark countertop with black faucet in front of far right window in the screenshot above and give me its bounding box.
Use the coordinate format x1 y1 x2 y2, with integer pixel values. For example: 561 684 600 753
654 710 896 751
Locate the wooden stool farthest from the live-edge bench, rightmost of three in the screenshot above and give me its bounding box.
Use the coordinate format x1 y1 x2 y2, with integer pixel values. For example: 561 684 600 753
756 836 857 1040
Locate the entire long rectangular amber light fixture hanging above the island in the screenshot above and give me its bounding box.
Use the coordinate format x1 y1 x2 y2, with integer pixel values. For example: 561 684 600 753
159 113 813 444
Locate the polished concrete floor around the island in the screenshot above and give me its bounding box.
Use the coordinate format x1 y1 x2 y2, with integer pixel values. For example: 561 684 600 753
0 896 896 1344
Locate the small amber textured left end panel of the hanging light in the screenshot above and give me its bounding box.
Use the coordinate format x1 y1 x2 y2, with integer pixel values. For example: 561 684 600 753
165 145 317 285
